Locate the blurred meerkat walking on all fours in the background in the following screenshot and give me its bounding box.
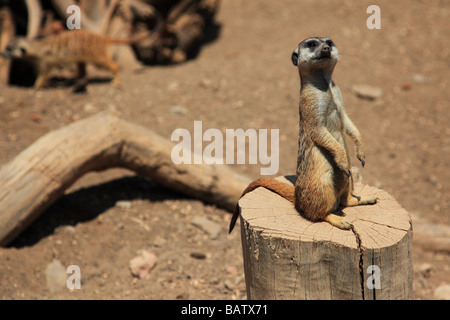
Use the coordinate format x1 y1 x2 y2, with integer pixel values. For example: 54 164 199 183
2 29 148 89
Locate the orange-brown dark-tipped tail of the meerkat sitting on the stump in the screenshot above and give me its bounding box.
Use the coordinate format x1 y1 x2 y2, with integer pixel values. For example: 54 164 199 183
228 178 295 233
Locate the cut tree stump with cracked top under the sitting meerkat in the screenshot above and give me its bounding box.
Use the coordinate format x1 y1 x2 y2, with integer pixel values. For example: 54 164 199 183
239 176 413 300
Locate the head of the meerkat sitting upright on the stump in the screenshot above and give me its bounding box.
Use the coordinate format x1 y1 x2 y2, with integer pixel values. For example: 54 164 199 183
291 37 339 71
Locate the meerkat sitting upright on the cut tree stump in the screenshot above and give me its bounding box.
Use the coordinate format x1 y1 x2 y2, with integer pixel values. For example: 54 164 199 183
229 37 378 232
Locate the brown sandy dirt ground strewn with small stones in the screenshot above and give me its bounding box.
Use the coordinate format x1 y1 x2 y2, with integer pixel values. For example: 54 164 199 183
0 0 450 299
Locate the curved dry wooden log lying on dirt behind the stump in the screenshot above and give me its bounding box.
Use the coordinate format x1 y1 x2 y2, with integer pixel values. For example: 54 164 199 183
0 113 250 246
